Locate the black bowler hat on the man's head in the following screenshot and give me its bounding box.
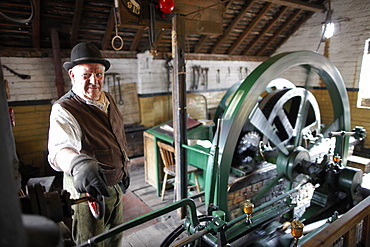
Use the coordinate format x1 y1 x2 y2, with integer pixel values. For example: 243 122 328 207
63 42 110 71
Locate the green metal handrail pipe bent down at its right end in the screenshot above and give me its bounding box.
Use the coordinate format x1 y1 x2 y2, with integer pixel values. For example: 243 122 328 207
79 198 199 247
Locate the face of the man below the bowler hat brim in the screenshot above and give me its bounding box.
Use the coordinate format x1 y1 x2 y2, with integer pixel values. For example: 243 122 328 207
68 63 105 100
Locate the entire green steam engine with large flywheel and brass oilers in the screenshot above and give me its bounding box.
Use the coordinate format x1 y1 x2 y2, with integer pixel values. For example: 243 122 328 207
82 51 369 246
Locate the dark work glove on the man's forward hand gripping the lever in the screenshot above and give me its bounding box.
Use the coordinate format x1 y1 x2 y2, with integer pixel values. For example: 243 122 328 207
69 154 110 198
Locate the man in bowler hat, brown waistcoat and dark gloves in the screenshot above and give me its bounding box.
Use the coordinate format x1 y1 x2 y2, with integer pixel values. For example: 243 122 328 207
48 43 130 246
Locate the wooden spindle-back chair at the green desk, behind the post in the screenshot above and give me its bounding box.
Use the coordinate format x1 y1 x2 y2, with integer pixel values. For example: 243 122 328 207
157 141 202 201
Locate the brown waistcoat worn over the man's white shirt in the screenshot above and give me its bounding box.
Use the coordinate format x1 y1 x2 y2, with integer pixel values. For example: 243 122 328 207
58 91 129 189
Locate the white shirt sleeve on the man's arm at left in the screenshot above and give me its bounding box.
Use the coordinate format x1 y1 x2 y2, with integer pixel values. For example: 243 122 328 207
48 103 82 171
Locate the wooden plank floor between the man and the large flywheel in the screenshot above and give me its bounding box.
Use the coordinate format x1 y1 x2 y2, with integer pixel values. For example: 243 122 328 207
122 159 205 247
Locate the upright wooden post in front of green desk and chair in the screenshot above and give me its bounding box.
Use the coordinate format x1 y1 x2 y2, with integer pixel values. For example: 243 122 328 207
172 15 188 217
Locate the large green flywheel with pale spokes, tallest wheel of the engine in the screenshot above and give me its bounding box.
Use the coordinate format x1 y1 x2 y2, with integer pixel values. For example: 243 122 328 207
205 51 351 218
